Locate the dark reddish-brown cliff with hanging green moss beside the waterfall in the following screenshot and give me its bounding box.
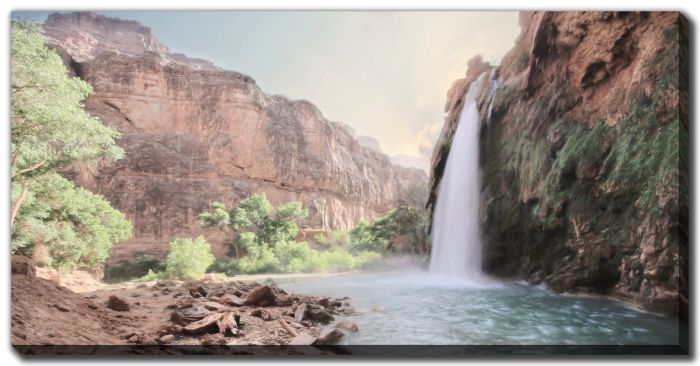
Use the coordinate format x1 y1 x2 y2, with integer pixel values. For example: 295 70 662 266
429 12 688 316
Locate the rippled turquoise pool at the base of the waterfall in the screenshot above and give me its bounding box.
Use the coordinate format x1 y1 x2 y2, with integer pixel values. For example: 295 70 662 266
277 271 679 345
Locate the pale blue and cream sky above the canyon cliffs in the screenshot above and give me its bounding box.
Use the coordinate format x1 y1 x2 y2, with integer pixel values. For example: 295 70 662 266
13 11 520 170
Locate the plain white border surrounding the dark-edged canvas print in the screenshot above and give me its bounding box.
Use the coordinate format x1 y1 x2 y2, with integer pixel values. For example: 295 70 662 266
0 0 700 365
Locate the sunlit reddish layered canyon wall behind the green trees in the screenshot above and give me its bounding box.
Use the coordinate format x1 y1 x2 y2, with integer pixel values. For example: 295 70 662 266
44 13 427 261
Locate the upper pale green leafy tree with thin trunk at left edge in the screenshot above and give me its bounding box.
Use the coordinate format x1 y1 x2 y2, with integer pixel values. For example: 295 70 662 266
10 22 124 225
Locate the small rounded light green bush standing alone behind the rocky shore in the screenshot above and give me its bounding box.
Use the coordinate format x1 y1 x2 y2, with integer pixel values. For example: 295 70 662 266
165 235 215 280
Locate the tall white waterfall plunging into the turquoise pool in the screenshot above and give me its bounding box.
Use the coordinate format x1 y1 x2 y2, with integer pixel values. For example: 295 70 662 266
430 73 488 282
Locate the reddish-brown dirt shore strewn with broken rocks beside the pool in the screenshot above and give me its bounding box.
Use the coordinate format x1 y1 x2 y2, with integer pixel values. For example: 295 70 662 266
12 256 358 353
